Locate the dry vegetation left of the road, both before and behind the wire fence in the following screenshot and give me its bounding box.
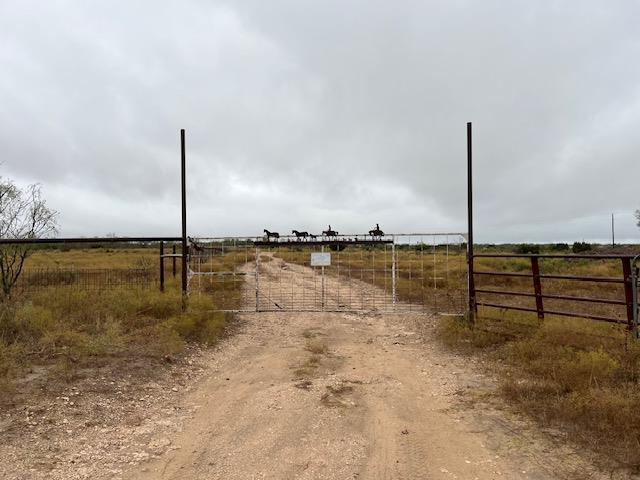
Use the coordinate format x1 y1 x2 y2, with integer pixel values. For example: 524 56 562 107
0 246 250 400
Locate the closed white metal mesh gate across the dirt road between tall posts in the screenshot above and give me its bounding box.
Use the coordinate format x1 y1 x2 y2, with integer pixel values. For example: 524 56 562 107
188 233 468 314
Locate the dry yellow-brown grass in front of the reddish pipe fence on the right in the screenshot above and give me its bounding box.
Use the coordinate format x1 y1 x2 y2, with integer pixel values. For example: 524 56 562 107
438 309 640 469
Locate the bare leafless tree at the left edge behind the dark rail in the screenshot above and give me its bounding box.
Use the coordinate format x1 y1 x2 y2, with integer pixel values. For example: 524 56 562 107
0 178 58 298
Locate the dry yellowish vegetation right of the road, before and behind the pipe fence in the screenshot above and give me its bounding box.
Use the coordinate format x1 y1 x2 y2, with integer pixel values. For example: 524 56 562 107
276 242 640 471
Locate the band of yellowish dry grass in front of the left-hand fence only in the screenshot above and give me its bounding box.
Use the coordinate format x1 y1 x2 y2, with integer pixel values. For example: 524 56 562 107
0 287 226 378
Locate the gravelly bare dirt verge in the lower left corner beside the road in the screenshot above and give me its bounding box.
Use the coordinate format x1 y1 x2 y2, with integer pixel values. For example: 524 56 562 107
0 346 214 480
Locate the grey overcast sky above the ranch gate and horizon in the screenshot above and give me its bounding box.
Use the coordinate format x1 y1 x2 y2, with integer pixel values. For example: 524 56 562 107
0 0 640 242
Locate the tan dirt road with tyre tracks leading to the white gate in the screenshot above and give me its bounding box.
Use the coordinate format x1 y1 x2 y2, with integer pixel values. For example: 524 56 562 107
125 261 600 480
